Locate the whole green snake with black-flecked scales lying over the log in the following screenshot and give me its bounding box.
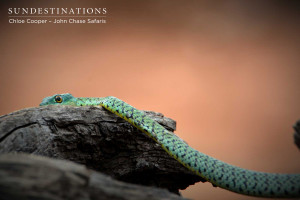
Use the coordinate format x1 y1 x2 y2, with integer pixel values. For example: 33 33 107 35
40 93 300 198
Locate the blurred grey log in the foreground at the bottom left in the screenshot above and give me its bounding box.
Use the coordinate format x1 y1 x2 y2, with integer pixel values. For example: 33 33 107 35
0 154 183 200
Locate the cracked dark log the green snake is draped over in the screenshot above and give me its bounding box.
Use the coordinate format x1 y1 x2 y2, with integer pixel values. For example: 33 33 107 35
0 106 202 196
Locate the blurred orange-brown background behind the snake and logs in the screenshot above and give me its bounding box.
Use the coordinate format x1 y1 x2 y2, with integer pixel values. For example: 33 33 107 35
0 0 300 199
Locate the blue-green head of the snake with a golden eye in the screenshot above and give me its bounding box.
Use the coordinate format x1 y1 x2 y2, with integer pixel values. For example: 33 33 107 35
40 93 76 106
